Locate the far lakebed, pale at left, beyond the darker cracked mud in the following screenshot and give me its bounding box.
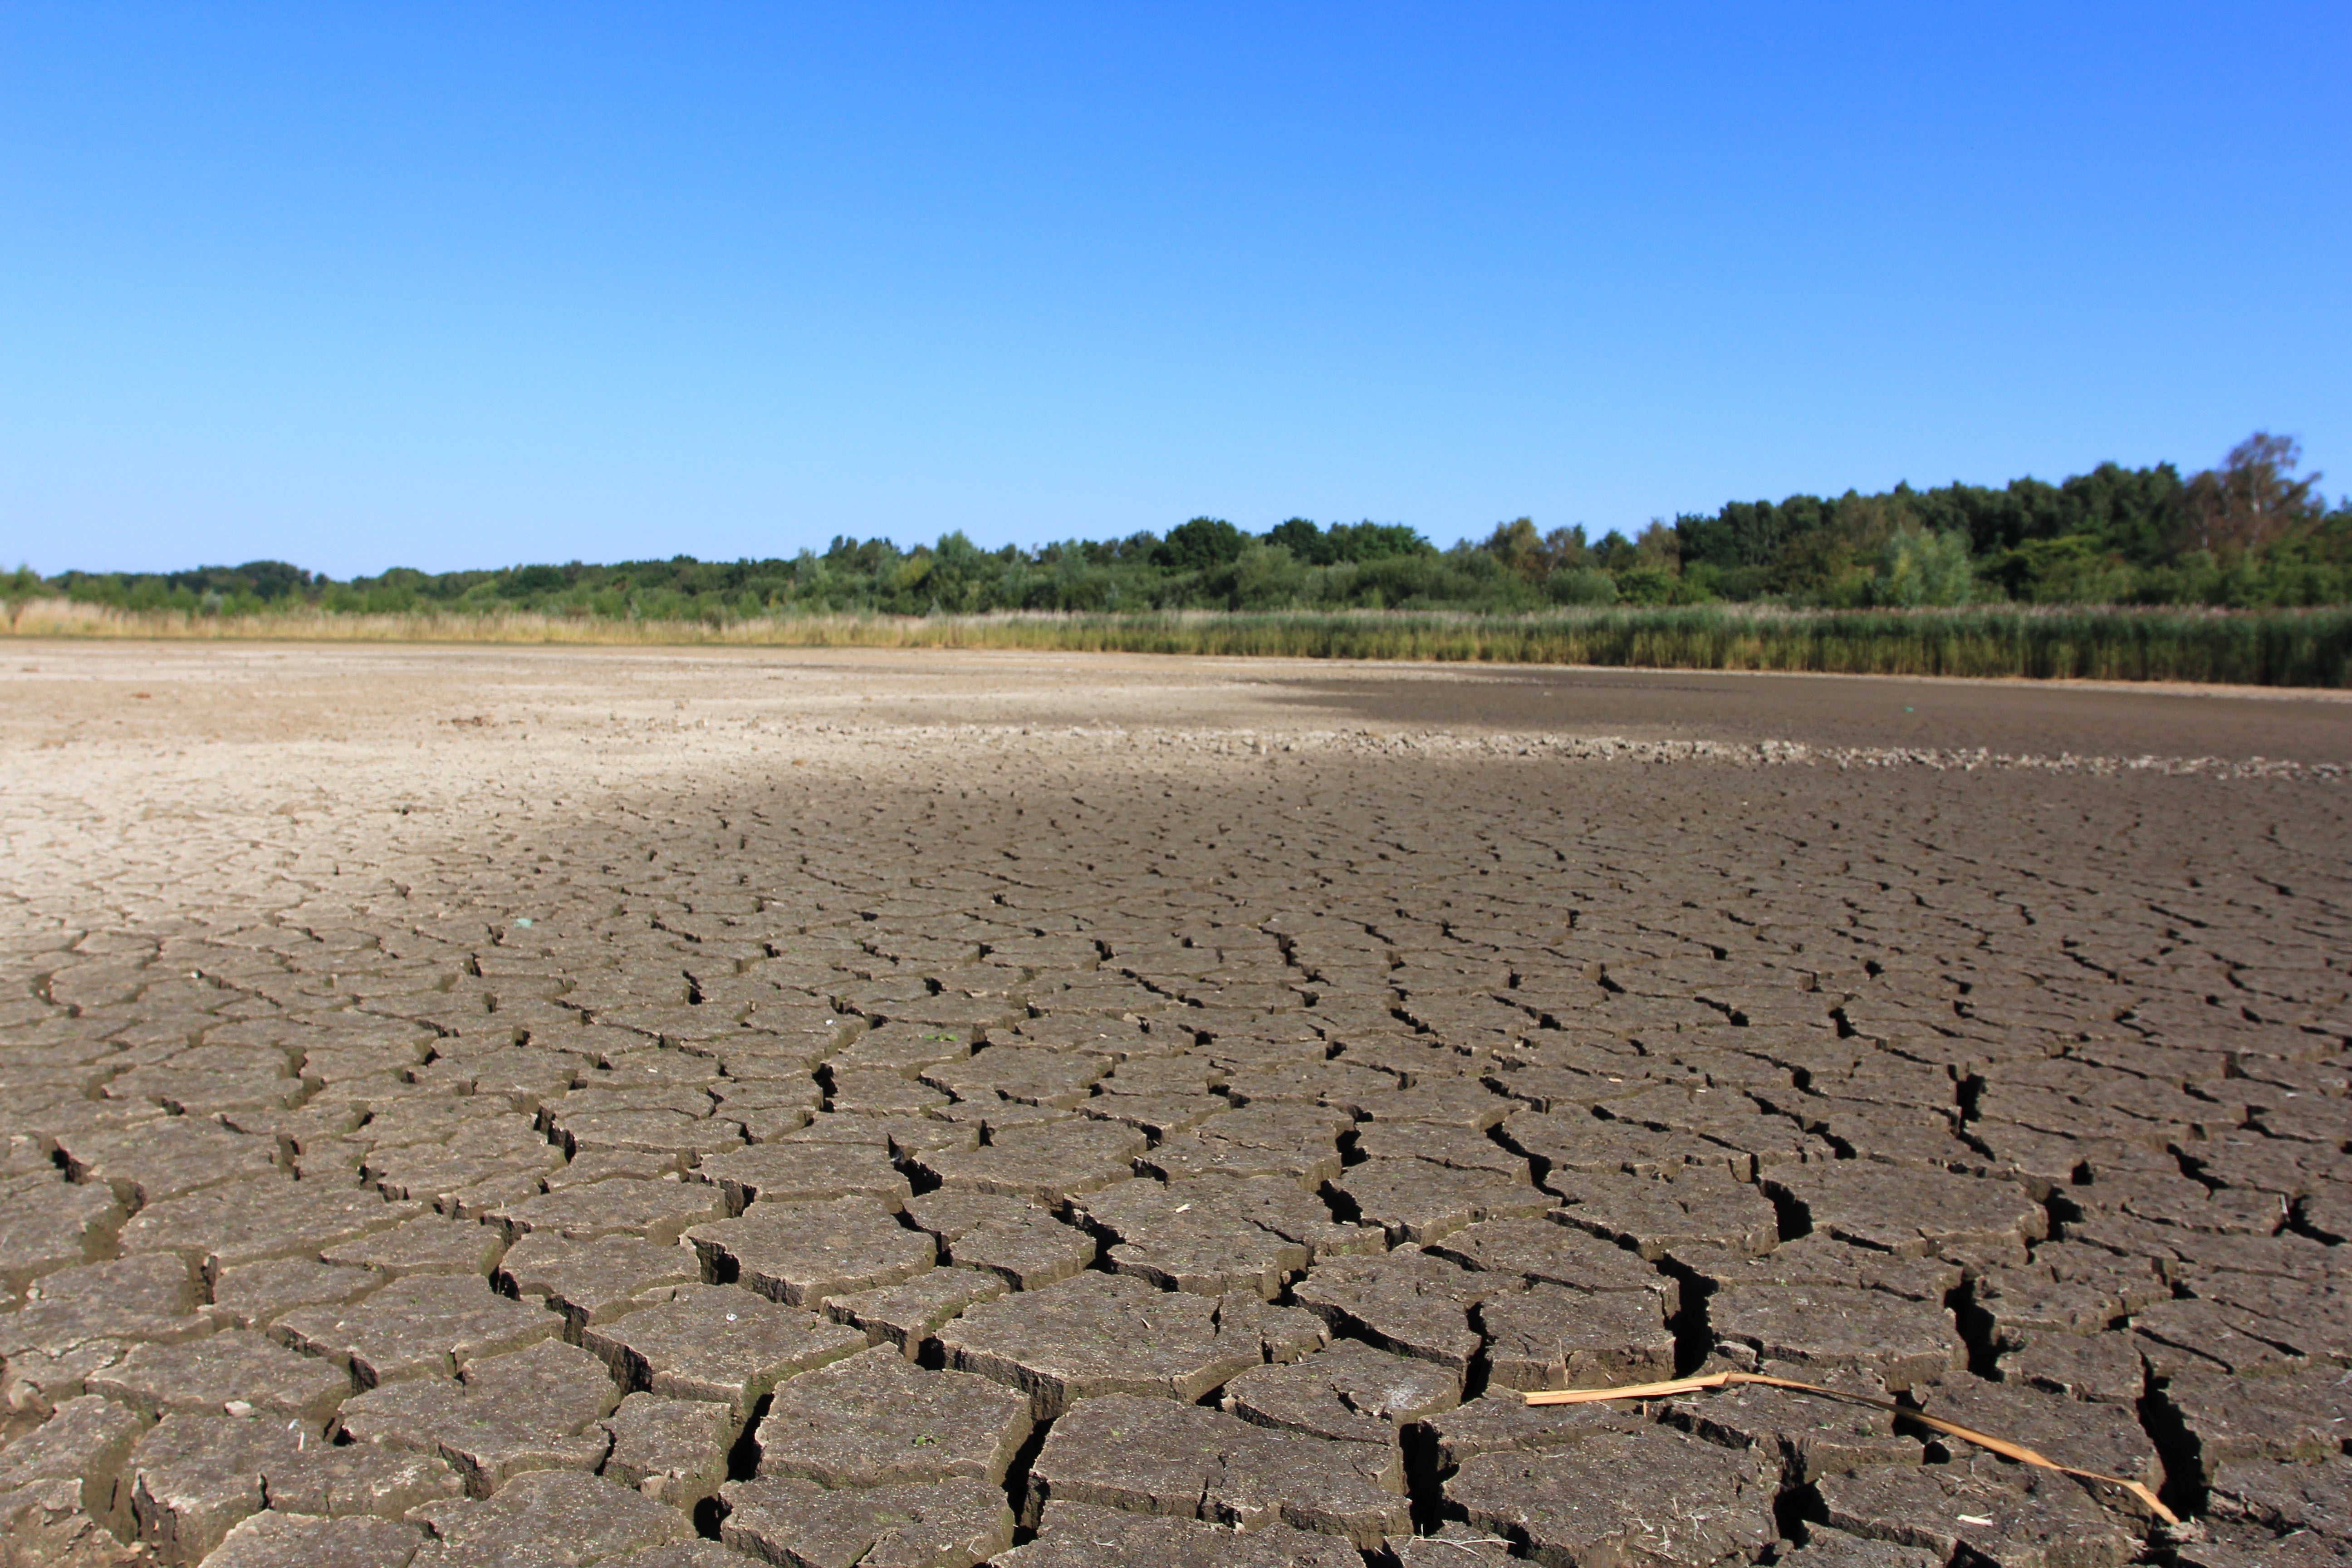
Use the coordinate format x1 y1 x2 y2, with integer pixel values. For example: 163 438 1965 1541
0 642 2352 959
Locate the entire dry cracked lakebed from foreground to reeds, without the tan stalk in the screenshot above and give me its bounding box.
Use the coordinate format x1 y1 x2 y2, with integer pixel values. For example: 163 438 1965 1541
0 642 2352 1568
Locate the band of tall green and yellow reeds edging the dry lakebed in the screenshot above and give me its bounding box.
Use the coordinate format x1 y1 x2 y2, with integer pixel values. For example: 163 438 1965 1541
7 599 2352 686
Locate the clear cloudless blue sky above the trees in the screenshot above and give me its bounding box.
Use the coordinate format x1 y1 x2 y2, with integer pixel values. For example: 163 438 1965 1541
0 0 2352 576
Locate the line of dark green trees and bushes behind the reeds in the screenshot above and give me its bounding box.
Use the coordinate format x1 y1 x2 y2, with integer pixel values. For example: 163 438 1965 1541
0 432 2352 618
